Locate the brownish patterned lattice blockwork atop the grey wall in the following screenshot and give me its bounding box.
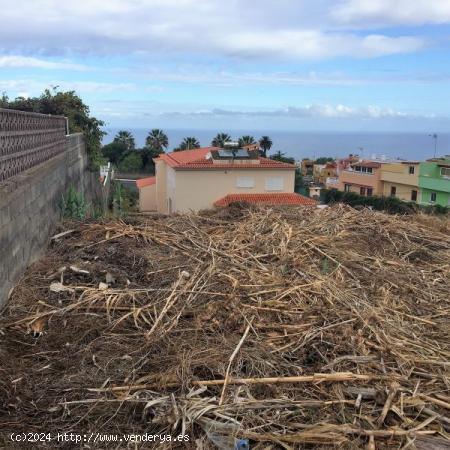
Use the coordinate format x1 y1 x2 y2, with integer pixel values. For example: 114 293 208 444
0 108 67 182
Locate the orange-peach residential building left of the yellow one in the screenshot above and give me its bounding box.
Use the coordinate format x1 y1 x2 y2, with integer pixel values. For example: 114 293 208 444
337 160 383 197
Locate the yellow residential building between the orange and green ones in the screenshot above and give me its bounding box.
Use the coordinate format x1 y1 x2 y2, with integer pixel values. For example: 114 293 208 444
380 161 419 202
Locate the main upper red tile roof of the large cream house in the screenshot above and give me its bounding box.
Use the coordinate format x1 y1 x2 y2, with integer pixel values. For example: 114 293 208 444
154 147 295 170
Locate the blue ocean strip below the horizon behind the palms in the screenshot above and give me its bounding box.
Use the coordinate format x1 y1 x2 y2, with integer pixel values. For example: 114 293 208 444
104 128 450 160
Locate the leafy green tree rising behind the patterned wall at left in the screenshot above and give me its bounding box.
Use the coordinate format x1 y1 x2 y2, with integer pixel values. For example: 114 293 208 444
2 86 105 169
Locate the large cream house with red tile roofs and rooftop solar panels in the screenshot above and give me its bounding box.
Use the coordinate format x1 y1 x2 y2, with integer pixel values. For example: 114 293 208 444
138 147 316 214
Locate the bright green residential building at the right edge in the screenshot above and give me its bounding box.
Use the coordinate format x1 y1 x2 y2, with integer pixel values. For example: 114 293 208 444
419 155 450 206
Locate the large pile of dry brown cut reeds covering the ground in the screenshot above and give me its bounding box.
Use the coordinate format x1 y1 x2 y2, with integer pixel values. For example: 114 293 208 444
0 206 450 450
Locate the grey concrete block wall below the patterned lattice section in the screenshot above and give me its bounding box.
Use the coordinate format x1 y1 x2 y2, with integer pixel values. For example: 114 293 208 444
0 134 101 308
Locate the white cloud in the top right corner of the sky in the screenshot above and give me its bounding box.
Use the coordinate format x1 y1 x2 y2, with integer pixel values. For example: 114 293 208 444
332 0 450 26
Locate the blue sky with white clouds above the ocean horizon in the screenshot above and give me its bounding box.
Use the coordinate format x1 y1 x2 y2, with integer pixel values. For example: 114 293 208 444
0 0 450 132
